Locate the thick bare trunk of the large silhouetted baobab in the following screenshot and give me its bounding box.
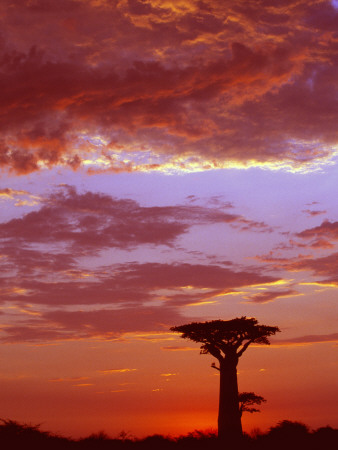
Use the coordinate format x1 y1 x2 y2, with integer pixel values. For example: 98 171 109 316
218 356 242 442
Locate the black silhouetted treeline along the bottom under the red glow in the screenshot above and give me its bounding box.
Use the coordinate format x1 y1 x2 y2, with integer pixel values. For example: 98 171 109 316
0 419 338 450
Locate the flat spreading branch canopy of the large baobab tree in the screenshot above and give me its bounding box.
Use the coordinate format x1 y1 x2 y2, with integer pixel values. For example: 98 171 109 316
170 316 280 360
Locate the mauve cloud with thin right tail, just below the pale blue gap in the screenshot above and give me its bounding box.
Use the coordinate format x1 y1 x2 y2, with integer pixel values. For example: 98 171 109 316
0 186 271 254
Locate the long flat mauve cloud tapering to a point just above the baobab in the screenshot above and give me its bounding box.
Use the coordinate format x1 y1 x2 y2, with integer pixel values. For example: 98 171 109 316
1 263 279 307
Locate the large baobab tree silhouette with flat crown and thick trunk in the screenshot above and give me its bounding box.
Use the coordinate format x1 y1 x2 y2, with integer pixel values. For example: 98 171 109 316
170 316 280 441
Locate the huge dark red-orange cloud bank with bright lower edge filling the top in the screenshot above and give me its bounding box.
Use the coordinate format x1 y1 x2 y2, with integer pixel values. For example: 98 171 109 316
0 0 338 174
